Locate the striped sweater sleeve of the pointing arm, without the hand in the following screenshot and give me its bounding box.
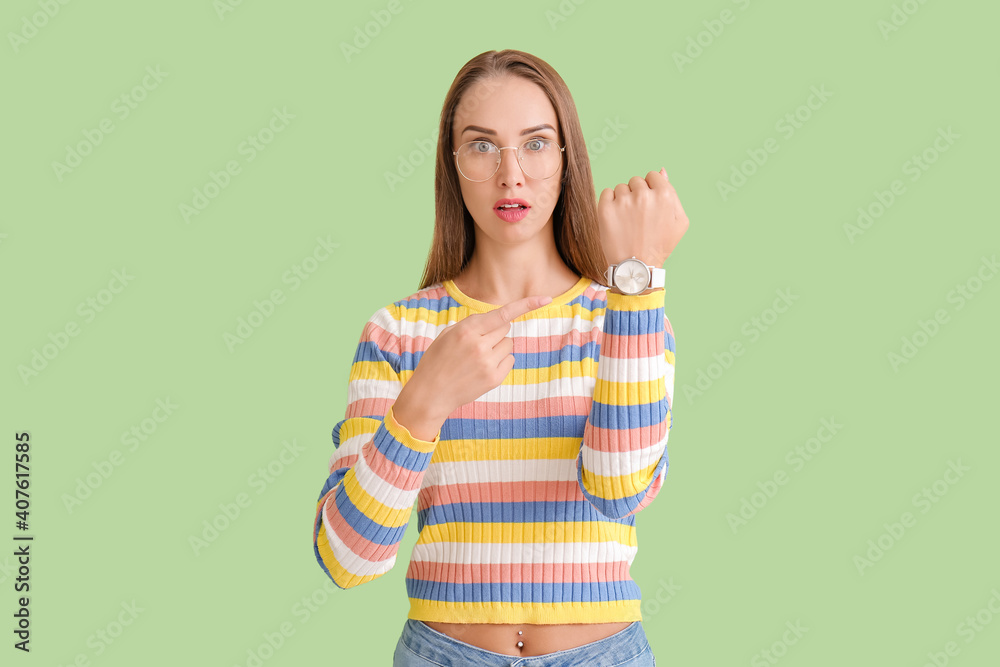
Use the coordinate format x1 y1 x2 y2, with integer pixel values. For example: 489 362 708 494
313 306 444 588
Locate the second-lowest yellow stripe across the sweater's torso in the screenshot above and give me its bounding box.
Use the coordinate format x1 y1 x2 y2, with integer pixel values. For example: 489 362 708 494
417 521 638 547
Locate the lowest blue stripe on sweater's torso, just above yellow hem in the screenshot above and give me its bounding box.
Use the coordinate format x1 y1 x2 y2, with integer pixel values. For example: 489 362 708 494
406 577 642 604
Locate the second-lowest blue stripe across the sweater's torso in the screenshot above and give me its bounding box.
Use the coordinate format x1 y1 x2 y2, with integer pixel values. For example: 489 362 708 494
417 499 635 530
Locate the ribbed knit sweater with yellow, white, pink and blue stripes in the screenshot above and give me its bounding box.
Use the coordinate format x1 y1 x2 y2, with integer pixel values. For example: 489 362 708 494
313 277 674 624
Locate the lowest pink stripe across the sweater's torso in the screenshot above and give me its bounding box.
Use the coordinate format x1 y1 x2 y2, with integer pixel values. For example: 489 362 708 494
406 560 632 584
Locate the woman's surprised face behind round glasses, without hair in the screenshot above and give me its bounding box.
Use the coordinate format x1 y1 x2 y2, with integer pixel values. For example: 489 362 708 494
452 77 565 252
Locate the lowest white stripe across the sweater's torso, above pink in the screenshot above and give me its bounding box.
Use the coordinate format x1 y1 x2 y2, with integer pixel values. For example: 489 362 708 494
410 541 639 565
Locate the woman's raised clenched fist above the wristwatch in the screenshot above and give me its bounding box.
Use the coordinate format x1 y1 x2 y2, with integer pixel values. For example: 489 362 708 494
597 169 688 267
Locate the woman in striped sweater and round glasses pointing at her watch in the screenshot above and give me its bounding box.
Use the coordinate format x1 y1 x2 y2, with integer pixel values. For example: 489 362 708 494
313 50 688 666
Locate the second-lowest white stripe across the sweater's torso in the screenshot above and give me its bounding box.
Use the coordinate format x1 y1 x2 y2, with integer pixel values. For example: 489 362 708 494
423 458 576 487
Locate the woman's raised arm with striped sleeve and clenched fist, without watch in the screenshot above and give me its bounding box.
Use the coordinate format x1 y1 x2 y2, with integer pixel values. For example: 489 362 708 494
577 170 688 518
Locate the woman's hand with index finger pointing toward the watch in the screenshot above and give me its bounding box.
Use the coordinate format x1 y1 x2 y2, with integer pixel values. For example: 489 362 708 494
394 296 552 425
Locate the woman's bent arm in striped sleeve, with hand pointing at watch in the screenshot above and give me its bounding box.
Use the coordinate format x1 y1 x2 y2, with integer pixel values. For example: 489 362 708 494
313 296 551 588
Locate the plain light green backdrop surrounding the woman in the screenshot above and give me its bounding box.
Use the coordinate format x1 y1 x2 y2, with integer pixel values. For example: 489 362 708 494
0 0 1000 666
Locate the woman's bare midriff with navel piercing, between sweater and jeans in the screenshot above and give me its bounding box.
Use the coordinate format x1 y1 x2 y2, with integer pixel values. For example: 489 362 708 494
422 621 632 657
